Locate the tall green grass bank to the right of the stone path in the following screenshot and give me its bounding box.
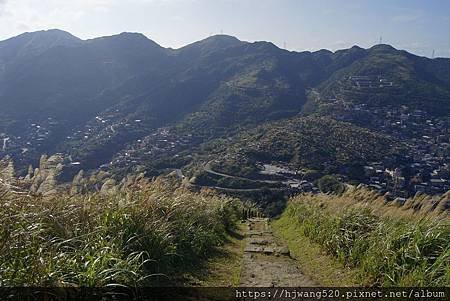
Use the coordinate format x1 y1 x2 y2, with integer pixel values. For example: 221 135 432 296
275 190 450 286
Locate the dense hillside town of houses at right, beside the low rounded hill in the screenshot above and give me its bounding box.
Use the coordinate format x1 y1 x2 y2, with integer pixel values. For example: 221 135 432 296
328 100 450 197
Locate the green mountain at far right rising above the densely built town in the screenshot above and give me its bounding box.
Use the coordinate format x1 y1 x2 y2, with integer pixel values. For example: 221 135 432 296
308 45 450 116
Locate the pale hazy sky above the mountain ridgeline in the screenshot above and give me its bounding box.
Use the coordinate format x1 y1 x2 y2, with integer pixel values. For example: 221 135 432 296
0 0 450 57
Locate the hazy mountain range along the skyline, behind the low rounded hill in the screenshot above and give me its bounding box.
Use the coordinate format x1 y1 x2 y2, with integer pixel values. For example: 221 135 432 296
0 30 450 176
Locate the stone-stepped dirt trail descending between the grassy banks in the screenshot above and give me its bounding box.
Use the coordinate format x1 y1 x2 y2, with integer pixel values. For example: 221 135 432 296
240 218 317 287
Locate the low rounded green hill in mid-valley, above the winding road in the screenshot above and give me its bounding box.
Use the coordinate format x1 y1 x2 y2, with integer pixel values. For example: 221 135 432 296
207 117 400 174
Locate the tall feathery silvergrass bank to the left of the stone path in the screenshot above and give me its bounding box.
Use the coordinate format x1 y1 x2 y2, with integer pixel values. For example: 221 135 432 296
0 180 241 287
